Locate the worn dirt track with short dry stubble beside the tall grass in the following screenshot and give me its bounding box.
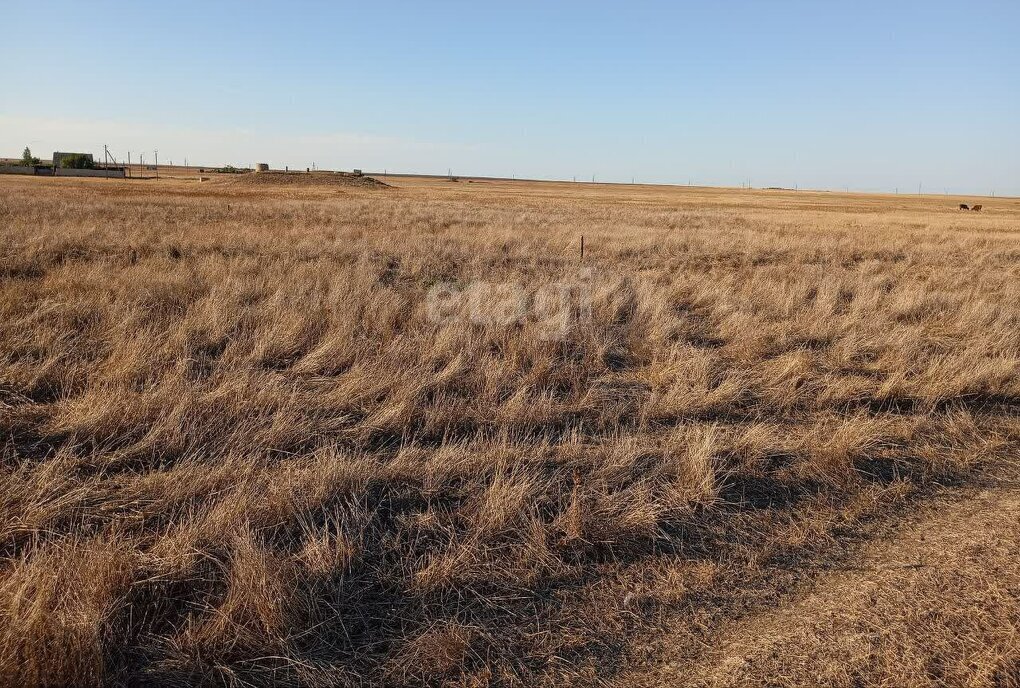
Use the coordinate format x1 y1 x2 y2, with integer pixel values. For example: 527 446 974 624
621 486 1020 687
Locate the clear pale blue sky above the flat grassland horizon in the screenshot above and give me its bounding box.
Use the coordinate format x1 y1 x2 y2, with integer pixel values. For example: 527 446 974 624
0 0 1020 195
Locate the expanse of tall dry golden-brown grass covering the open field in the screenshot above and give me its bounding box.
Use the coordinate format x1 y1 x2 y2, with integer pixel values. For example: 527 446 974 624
0 173 1020 686
